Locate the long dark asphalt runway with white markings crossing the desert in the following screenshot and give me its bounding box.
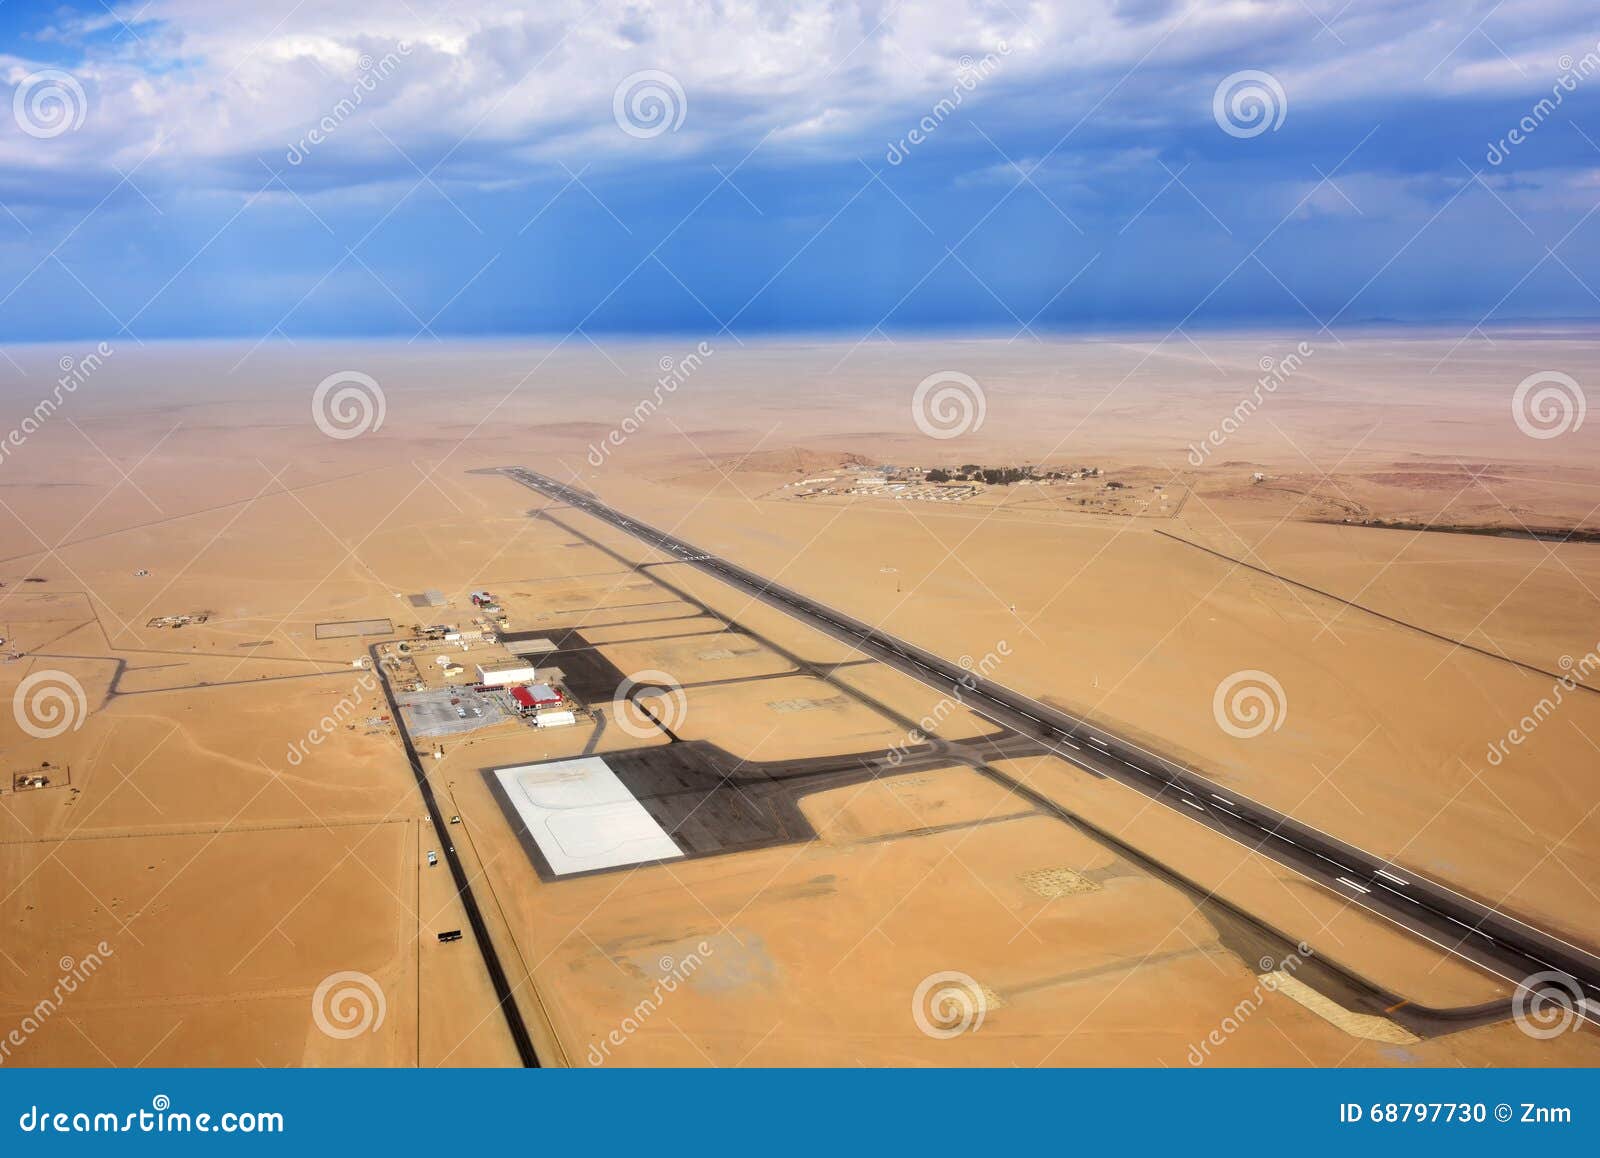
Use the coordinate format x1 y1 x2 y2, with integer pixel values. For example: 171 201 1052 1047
501 467 1600 1020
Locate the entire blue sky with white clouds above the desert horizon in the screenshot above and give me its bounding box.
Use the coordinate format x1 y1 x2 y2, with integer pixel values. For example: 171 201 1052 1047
0 0 1600 342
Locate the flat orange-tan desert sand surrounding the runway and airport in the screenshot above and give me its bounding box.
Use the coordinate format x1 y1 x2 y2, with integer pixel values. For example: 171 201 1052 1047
0 333 1600 1065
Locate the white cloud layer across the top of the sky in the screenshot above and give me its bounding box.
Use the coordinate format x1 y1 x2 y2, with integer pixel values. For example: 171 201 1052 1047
0 0 1592 199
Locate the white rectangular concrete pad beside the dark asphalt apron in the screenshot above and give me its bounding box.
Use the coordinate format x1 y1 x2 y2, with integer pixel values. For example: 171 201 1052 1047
494 757 683 876
